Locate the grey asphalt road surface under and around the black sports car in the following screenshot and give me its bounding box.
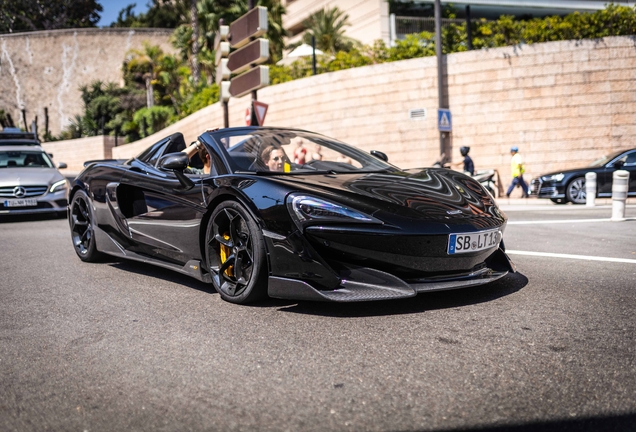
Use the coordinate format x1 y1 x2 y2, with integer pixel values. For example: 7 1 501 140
0 205 636 431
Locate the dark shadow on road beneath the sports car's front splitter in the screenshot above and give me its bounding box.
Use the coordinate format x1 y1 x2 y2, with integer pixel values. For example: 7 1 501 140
279 272 528 317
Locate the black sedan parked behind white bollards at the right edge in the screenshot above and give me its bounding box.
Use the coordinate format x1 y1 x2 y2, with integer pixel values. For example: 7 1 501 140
530 149 636 204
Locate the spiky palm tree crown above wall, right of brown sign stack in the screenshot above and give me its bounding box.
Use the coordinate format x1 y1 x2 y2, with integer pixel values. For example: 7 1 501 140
302 7 360 54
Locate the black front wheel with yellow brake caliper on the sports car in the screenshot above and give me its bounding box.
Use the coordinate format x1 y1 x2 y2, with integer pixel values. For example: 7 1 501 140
206 201 267 304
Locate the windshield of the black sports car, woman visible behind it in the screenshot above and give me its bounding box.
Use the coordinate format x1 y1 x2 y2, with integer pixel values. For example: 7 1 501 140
215 129 395 175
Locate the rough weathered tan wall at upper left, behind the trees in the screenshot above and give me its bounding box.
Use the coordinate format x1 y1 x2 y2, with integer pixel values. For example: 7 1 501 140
0 28 174 136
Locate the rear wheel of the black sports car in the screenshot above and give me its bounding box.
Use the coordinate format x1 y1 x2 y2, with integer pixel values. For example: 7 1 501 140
68 190 102 262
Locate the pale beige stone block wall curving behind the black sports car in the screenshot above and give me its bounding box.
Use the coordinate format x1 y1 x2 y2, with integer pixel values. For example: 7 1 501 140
102 36 636 197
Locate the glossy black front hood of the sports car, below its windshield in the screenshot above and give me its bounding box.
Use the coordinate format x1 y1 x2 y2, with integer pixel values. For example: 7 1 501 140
270 168 505 228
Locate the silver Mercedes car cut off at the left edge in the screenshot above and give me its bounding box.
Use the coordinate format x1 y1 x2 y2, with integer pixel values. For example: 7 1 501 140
0 145 68 217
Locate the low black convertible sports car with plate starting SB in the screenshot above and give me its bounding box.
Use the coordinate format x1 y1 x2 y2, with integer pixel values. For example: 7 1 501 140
69 127 514 303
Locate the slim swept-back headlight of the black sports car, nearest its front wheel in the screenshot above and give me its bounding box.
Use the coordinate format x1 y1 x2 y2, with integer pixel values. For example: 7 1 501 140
287 194 382 228
